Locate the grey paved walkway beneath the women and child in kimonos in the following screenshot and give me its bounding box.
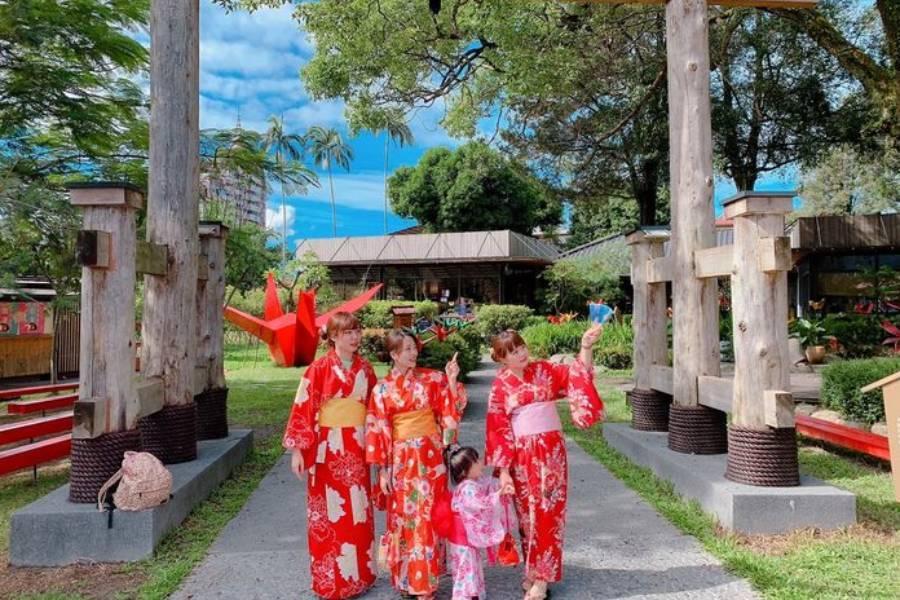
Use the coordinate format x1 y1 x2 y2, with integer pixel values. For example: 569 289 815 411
173 365 756 600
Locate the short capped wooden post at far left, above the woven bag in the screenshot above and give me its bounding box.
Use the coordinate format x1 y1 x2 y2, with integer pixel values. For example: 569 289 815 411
70 183 144 439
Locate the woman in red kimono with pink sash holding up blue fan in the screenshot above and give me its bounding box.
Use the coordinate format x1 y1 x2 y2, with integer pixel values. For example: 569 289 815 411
485 325 603 600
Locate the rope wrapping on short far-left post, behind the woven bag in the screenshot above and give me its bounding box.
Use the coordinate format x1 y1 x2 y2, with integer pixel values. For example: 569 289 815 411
69 429 141 504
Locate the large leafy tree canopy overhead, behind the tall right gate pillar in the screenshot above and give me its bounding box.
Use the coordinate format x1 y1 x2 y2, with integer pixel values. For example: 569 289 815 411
220 0 884 231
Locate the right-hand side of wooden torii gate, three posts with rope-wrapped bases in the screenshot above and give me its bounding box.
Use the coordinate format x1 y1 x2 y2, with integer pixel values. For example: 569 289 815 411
601 0 817 485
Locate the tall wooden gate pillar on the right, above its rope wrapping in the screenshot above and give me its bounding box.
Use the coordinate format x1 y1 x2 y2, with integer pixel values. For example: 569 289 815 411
666 0 719 406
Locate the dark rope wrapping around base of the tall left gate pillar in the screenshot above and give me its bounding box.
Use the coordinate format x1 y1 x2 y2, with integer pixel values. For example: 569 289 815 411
138 402 197 465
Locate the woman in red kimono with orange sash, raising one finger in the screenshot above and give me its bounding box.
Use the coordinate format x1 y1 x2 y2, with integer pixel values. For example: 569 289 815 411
366 331 466 598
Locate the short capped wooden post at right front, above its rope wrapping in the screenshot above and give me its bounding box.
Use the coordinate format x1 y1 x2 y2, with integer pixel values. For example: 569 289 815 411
725 192 794 430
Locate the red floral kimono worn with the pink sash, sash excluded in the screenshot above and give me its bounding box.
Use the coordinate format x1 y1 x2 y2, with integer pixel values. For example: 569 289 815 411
485 360 603 582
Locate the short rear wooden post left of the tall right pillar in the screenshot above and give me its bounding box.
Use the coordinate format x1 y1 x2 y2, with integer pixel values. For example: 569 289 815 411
626 231 668 390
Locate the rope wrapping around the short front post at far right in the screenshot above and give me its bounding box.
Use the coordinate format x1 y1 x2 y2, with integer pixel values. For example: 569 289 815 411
725 425 800 487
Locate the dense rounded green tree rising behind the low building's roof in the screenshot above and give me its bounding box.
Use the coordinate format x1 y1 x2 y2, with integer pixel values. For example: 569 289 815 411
388 142 562 233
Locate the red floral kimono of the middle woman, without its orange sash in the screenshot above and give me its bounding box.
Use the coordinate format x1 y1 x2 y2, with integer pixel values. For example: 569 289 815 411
366 369 466 595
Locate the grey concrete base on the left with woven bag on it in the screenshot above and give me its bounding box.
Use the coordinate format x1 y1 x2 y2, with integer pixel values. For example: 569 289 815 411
9 430 253 567
